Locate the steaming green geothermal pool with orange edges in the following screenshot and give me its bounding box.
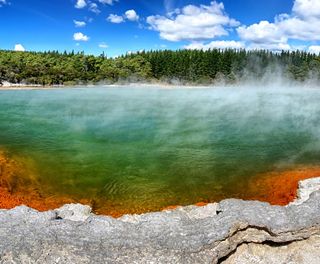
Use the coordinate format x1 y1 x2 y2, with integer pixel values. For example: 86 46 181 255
0 87 320 215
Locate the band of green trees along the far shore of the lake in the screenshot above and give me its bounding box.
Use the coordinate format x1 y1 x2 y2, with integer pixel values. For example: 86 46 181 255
0 49 320 85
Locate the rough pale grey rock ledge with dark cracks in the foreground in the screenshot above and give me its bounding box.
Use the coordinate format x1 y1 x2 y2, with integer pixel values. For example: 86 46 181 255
0 178 320 263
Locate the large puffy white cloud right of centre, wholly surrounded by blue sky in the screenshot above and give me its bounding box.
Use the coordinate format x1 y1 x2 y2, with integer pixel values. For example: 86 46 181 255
147 1 239 41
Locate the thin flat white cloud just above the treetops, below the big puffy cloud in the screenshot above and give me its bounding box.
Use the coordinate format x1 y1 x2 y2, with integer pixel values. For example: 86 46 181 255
184 40 245 50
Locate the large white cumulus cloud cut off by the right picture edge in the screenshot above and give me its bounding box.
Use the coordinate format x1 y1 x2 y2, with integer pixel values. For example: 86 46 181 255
237 0 320 49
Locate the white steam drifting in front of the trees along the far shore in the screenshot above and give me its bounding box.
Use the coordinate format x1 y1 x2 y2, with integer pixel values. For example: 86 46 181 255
91 55 320 88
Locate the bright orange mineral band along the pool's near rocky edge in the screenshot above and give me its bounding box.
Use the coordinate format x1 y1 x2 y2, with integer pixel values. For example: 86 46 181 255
0 147 320 218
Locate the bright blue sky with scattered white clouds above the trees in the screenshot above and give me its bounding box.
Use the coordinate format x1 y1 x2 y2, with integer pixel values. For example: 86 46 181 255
0 0 320 57
